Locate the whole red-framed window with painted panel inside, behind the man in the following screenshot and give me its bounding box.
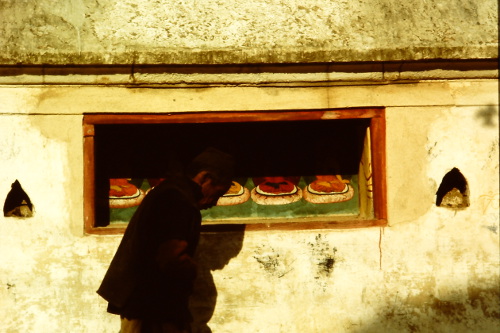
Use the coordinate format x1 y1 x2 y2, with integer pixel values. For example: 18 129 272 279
83 108 387 234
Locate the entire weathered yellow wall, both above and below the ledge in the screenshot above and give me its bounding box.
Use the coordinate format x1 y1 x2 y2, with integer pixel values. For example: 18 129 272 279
0 0 500 333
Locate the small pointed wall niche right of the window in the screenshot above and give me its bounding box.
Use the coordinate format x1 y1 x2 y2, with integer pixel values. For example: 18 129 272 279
436 168 470 209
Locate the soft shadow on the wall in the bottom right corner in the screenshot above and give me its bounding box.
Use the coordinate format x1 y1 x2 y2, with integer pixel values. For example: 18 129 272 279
350 283 500 333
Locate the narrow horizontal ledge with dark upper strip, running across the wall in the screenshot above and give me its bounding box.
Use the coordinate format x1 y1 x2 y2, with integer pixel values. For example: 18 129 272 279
0 59 498 86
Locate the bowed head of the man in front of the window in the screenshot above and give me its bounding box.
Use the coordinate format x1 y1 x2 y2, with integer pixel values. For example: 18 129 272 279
186 148 234 209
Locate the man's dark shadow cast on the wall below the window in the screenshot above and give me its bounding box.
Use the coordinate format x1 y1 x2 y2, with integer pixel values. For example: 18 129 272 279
190 226 244 333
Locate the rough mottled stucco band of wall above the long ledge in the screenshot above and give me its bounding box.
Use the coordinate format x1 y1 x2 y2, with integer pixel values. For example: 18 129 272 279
0 0 498 65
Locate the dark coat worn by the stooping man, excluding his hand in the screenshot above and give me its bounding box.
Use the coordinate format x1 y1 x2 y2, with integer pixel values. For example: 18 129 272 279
97 177 202 322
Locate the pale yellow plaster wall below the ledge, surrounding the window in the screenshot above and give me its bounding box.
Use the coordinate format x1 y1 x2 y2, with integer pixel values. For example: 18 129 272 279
0 79 500 333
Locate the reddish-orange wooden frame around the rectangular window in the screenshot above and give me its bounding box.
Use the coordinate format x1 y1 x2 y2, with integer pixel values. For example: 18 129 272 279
83 107 387 234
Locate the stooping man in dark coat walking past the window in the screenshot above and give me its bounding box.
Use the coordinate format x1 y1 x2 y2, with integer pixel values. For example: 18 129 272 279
97 148 234 333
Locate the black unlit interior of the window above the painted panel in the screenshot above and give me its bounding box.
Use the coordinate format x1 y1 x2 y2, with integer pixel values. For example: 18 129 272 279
95 119 370 226
